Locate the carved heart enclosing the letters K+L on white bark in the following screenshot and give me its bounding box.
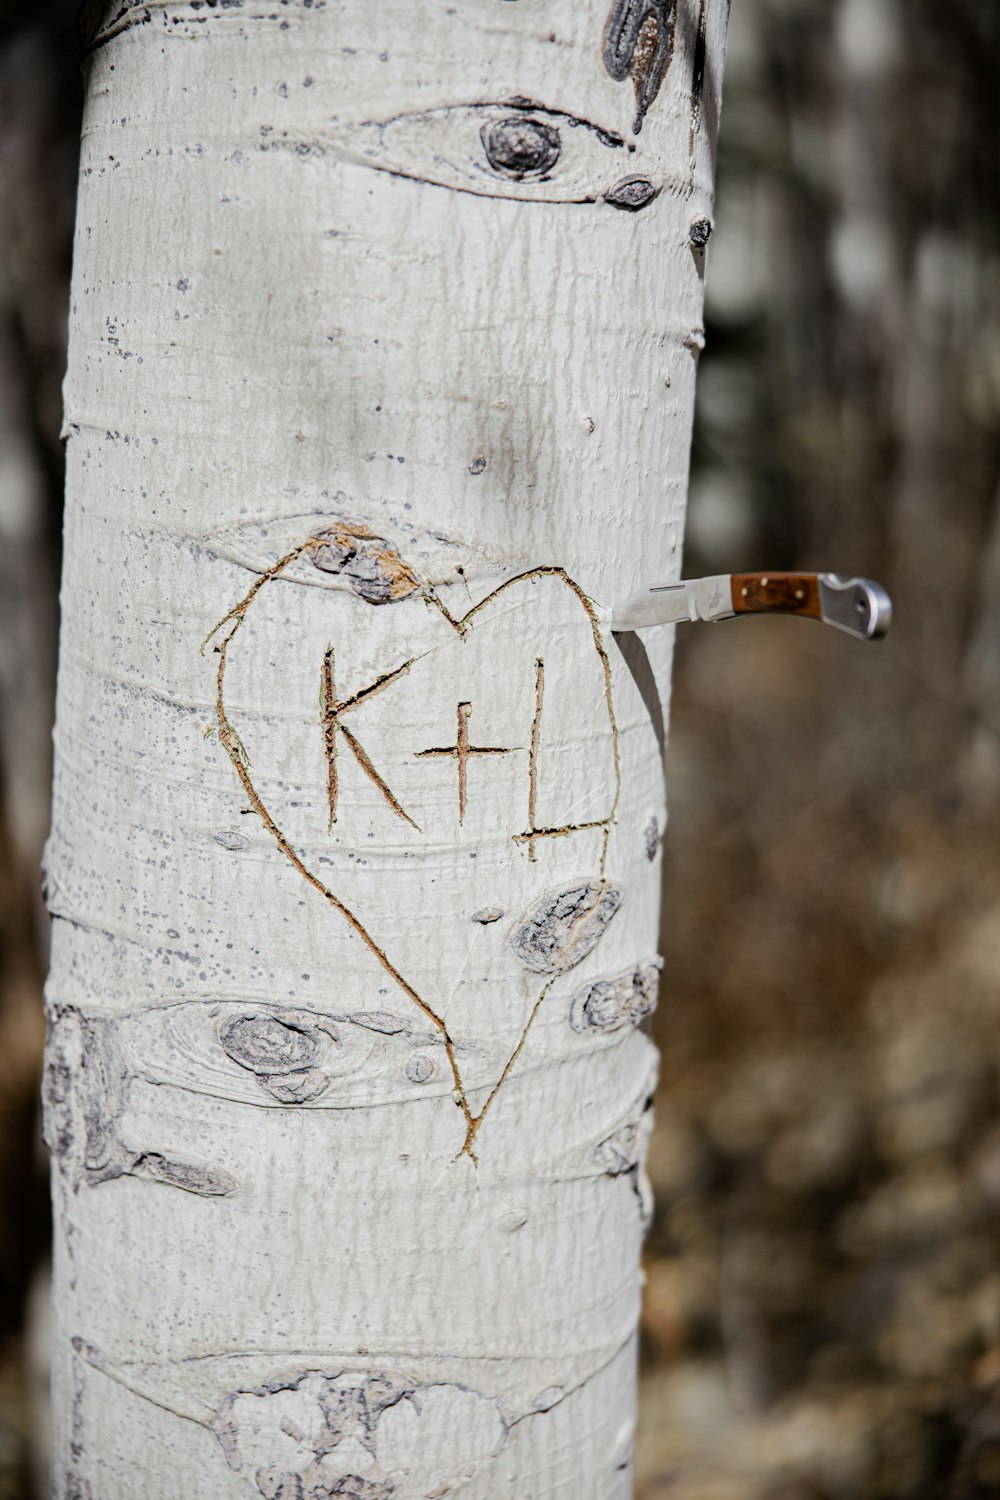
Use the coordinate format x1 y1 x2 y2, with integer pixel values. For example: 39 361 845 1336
210 522 621 1157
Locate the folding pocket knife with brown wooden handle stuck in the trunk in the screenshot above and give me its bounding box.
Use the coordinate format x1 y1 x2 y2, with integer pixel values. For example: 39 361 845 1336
612 573 892 641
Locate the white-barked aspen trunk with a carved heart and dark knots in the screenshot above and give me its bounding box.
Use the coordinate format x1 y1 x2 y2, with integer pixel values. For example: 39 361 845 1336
46 0 726 1500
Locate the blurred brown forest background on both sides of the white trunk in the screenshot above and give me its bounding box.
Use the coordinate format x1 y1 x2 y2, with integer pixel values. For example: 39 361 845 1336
0 0 1000 1500
